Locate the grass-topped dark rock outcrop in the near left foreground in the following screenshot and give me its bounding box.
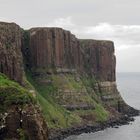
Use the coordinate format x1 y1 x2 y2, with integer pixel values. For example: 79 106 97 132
0 73 48 140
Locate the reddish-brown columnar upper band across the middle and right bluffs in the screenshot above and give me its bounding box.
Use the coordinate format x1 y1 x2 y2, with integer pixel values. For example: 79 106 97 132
29 28 116 81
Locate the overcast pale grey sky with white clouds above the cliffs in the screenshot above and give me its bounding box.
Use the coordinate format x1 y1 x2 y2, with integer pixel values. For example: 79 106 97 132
0 0 140 72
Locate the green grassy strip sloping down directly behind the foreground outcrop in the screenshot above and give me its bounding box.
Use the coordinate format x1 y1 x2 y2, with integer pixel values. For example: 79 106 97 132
27 72 81 128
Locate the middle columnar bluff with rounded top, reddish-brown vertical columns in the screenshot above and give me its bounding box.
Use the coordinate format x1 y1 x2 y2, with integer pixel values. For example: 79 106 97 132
30 28 79 69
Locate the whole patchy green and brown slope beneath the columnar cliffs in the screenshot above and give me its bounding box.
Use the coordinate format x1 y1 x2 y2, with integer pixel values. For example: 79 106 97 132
27 72 109 129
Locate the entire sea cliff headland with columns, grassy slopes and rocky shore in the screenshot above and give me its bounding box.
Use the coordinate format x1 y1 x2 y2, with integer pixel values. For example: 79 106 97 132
0 22 138 140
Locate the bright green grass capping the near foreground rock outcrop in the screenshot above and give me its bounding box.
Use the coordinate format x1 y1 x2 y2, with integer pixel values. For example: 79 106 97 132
0 73 33 111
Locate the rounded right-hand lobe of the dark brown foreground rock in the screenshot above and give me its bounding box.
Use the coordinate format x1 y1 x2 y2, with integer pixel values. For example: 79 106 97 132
22 105 48 140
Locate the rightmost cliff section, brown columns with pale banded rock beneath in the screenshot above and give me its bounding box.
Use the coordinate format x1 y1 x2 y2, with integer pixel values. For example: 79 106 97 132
79 40 118 110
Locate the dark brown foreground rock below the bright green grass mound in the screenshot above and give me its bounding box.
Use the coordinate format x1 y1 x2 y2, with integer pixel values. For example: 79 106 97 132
5 104 48 140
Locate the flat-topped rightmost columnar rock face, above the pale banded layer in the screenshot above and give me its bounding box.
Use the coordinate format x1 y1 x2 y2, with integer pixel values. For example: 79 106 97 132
79 40 116 81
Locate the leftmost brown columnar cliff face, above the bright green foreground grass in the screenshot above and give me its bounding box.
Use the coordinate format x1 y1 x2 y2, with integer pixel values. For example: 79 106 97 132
0 22 23 83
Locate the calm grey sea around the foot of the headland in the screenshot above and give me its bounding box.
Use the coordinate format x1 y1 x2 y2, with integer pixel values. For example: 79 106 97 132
65 73 140 140
